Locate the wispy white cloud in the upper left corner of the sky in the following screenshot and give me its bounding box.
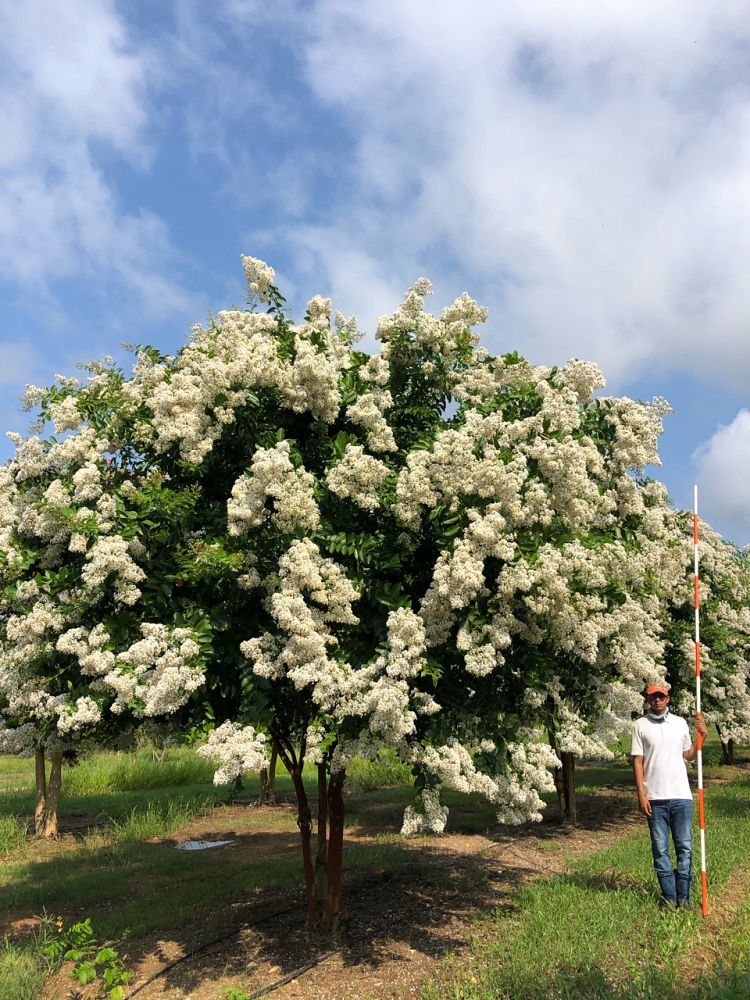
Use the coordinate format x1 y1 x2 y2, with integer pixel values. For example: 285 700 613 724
0 0 187 311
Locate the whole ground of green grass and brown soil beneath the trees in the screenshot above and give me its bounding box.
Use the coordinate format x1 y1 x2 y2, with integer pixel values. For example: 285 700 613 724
0 748 750 1000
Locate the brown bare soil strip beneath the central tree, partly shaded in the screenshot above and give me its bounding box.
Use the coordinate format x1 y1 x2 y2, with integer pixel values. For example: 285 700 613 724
91 788 641 1000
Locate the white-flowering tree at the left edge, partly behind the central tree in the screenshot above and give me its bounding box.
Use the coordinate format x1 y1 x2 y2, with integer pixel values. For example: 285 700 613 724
0 365 210 836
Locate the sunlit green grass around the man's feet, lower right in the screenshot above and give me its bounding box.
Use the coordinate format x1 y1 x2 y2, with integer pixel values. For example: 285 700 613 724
423 776 750 1000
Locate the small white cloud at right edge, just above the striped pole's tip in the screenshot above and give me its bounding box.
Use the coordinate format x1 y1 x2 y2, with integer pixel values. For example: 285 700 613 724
693 409 750 543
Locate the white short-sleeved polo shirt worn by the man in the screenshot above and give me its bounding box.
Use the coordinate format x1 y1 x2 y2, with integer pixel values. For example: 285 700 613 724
630 711 693 799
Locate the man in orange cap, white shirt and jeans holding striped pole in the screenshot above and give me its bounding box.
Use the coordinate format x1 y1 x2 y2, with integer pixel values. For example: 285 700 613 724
630 681 708 909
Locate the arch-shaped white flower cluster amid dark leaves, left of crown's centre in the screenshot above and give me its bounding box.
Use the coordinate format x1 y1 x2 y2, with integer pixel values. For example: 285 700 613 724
227 441 320 535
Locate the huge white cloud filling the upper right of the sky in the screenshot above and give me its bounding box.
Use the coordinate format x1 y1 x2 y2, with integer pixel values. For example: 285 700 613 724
219 0 750 384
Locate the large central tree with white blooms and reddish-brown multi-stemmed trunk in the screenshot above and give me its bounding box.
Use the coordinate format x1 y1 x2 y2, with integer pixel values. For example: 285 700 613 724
5 258 700 927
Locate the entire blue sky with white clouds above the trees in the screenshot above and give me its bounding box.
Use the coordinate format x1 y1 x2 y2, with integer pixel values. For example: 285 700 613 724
0 0 750 544
